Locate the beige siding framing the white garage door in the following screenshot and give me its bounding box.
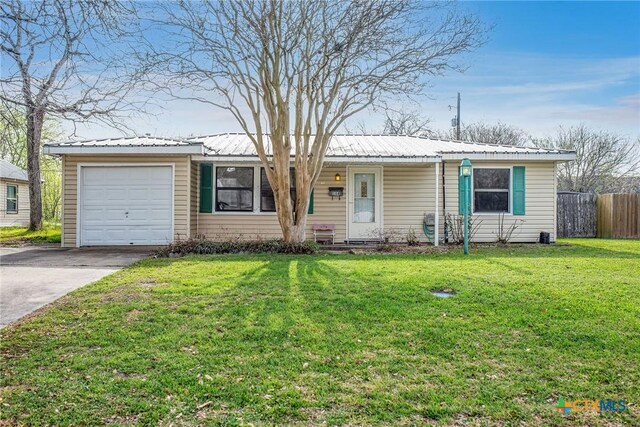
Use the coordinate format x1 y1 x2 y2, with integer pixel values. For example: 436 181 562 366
62 155 190 247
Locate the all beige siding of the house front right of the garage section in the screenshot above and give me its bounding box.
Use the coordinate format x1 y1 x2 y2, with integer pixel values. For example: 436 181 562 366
192 161 555 242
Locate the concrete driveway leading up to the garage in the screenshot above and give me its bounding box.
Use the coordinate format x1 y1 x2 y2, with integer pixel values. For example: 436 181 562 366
0 246 151 328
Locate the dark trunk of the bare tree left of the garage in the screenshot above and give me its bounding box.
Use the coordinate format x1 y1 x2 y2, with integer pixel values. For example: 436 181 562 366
27 107 44 231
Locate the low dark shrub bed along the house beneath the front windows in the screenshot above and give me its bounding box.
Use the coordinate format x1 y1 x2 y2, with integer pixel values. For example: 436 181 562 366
156 239 320 257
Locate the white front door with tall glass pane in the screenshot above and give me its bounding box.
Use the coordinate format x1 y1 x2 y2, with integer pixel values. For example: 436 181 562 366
347 167 382 240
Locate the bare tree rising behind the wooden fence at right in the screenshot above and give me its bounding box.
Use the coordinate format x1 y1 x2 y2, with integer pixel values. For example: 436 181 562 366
536 125 640 192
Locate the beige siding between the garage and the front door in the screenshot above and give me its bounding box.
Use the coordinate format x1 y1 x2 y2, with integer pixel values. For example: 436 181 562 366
196 165 346 242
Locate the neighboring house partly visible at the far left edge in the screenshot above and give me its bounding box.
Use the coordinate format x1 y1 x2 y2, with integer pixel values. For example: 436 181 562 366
0 159 29 227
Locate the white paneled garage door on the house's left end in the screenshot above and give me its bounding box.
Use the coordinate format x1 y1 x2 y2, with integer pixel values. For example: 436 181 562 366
80 166 173 246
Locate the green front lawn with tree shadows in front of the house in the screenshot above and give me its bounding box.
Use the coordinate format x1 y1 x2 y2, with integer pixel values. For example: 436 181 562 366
0 240 640 426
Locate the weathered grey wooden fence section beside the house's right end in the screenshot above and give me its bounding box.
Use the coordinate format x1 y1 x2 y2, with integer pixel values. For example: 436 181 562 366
558 192 597 237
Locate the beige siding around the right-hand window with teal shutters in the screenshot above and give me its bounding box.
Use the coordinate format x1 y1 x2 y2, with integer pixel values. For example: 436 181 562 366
440 161 556 242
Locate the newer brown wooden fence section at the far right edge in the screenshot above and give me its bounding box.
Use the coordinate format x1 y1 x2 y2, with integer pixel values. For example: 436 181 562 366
596 194 640 239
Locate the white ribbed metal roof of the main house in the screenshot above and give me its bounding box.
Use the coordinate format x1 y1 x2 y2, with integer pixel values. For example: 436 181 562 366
45 133 575 162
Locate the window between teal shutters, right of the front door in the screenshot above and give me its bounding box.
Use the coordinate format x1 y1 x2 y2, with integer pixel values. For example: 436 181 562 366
473 168 511 212
